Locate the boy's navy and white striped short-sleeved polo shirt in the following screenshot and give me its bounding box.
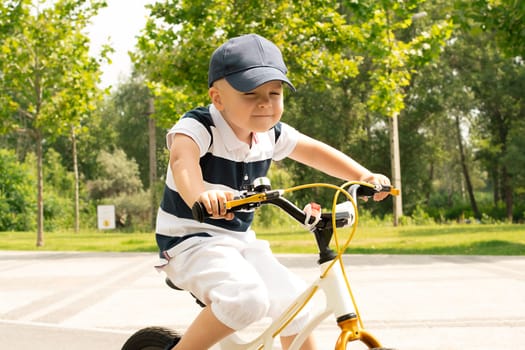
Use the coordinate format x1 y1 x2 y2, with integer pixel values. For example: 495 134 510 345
156 105 299 257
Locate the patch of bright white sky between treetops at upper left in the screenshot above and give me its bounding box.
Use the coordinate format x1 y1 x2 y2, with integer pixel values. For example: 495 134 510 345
87 0 155 88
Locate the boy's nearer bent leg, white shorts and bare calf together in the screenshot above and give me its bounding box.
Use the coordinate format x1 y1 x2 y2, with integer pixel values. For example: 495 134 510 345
163 237 269 350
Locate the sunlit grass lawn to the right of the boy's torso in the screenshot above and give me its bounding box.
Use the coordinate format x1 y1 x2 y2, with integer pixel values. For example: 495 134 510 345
259 225 525 255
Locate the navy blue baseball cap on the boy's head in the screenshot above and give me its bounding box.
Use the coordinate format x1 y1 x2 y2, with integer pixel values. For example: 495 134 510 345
208 34 295 92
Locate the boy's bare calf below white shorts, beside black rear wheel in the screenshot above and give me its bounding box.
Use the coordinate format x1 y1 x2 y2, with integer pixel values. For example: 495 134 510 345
173 307 233 350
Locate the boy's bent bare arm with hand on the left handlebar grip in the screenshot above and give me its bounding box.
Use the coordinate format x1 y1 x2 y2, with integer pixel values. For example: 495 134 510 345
170 134 233 219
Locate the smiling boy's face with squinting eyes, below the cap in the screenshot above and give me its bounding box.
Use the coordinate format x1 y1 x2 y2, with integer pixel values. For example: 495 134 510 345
209 79 284 142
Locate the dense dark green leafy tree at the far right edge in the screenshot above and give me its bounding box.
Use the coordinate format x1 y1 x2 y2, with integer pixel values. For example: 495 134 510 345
438 8 525 221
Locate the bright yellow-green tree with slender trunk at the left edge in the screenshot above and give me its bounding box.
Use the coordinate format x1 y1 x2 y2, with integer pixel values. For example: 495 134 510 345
0 0 105 246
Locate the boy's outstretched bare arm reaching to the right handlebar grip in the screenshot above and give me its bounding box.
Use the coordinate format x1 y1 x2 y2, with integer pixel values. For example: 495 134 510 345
289 134 390 200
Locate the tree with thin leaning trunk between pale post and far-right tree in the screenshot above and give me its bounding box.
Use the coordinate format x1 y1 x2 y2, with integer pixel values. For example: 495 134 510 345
404 24 481 219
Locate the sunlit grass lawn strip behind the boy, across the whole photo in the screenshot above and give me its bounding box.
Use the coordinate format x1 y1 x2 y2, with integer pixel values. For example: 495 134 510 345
0 224 525 255
